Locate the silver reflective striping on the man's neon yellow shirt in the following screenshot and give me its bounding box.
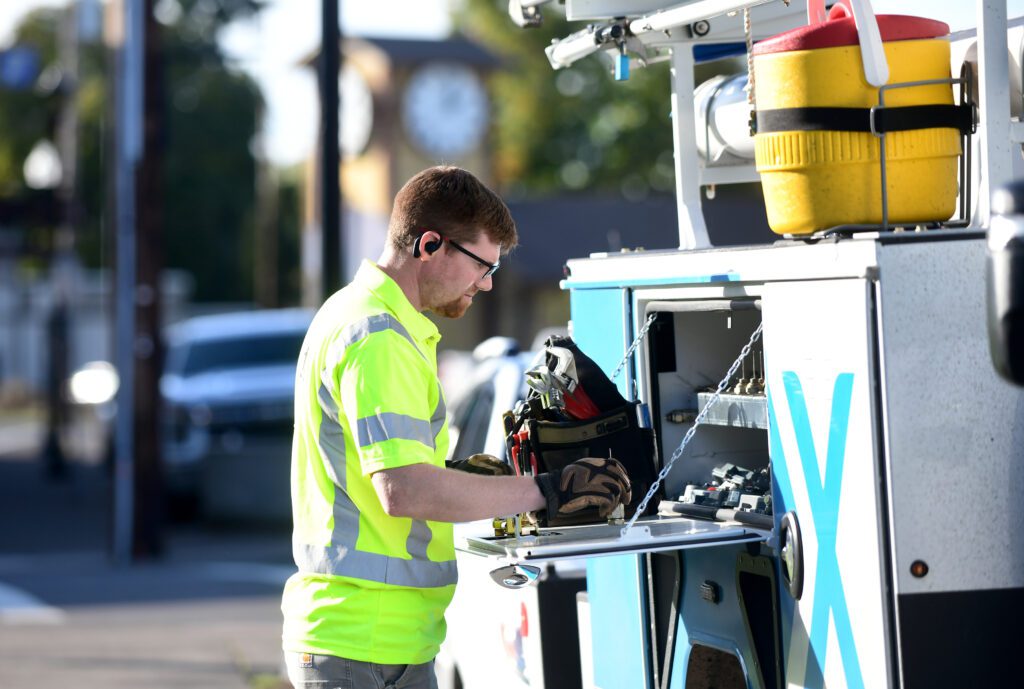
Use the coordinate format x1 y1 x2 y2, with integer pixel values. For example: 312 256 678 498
292 313 458 588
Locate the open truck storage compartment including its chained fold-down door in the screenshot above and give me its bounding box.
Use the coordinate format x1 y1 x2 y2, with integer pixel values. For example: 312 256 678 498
460 298 771 562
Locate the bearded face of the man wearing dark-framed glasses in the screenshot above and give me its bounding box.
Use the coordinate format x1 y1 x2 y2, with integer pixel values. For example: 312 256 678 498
421 232 501 318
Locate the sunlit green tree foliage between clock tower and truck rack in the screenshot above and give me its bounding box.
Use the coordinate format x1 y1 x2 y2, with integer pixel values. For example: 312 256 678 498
456 0 674 199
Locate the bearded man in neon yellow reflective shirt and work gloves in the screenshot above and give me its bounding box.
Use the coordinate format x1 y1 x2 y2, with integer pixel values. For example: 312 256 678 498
282 167 630 689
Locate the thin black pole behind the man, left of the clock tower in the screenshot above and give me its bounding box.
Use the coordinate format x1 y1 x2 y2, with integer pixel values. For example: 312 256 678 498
319 0 343 298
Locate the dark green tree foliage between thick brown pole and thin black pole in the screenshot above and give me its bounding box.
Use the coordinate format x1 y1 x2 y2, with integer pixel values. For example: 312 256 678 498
164 11 262 301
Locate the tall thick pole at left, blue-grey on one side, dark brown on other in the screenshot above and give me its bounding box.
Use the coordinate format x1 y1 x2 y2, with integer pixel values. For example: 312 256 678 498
111 0 164 564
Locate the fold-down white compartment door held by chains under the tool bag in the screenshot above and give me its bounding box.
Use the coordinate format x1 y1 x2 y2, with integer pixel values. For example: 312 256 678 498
456 517 771 563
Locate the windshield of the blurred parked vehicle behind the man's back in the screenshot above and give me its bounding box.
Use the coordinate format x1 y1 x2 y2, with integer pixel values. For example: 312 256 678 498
181 333 305 377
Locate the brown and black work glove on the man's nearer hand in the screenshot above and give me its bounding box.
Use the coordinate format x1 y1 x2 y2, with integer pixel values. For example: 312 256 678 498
535 457 632 519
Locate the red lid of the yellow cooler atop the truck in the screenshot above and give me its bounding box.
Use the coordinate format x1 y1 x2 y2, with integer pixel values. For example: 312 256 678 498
754 5 949 55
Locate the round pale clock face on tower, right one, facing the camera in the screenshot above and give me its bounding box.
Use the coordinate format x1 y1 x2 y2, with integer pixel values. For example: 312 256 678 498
401 62 488 159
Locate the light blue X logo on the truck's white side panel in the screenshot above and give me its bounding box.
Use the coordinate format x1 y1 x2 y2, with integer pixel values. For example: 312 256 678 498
768 371 864 689
